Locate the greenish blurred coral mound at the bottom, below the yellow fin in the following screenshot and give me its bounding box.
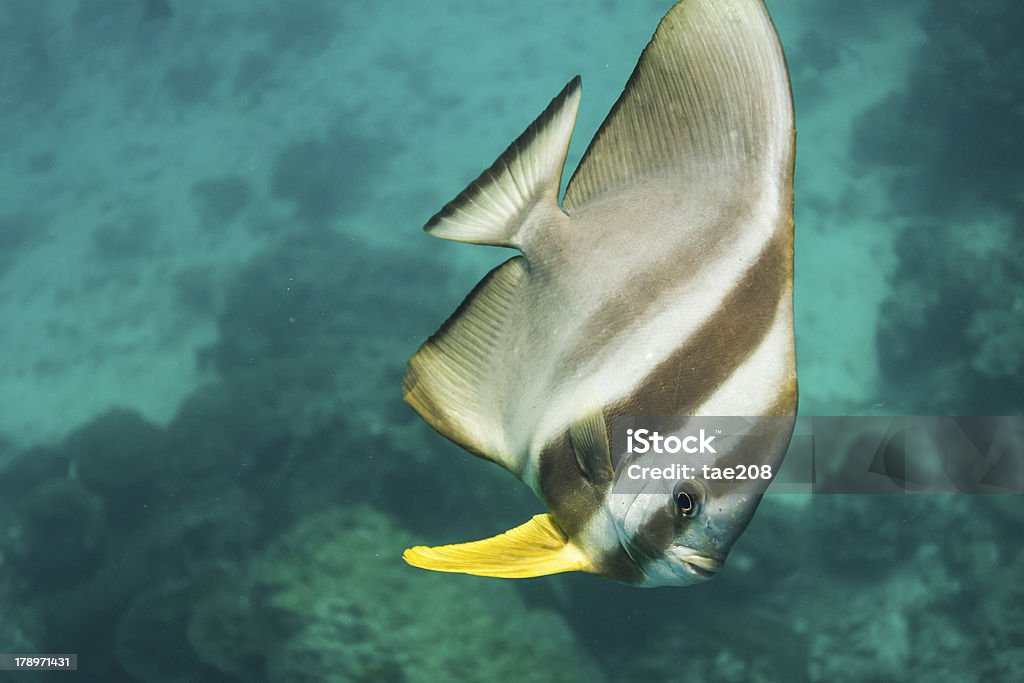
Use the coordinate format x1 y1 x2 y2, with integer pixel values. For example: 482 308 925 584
118 507 602 683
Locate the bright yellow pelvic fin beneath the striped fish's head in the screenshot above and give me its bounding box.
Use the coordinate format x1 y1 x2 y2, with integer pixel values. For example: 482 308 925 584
401 515 594 579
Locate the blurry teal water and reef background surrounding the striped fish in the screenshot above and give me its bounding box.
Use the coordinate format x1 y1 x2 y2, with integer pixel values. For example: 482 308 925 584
0 0 1024 683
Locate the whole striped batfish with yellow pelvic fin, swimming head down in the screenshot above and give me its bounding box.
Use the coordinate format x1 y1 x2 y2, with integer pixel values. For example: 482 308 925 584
403 0 797 586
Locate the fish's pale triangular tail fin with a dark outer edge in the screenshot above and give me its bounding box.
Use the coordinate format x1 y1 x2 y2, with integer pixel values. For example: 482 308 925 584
424 76 581 248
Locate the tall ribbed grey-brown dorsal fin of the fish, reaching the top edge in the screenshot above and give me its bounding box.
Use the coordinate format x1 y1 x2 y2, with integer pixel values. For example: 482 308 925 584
562 0 794 215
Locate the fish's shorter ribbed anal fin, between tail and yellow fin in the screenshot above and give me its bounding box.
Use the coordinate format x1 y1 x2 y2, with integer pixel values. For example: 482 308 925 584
402 256 526 472
